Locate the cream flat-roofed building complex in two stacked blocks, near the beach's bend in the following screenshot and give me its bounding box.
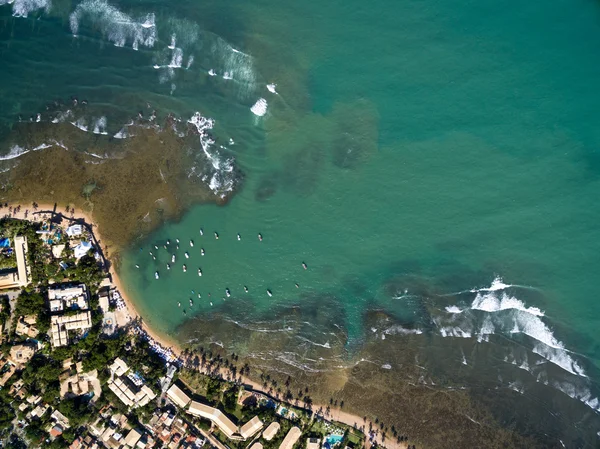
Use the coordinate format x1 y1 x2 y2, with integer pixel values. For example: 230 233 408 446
48 284 92 348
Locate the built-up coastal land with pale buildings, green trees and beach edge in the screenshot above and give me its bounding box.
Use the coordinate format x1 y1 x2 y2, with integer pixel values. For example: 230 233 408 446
0 203 414 449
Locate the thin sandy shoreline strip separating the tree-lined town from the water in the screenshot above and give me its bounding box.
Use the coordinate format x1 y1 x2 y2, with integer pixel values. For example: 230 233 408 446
4 203 408 449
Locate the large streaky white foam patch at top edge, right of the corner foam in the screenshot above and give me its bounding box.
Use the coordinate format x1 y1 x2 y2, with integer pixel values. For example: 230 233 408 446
69 0 156 49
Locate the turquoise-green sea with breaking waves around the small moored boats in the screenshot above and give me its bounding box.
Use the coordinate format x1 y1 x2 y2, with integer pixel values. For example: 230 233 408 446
0 0 600 447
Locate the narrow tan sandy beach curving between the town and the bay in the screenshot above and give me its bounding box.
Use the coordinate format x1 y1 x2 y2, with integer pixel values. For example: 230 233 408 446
4 203 407 449
